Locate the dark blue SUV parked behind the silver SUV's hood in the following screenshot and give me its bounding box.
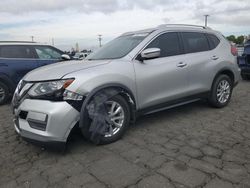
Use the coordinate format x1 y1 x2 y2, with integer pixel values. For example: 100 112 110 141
0 41 70 104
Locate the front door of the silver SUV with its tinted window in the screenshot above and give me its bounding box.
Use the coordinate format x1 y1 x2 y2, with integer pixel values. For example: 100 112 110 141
134 32 189 109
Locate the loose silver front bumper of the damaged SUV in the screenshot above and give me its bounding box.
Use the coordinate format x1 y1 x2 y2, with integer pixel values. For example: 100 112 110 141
14 99 79 144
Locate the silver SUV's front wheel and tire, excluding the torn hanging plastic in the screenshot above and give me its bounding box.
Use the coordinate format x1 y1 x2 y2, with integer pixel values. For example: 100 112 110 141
81 95 130 144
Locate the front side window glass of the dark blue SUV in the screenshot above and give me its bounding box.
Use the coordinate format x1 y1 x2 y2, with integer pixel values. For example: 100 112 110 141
34 46 62 59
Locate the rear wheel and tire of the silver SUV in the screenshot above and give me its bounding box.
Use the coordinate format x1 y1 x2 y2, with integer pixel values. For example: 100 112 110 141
208 74 233 108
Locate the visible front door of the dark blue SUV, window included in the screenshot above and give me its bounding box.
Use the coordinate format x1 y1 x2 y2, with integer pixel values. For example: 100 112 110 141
33 45 63 66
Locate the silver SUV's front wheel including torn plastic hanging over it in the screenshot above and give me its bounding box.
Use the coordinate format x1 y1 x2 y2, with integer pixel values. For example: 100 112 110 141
81 95 130 144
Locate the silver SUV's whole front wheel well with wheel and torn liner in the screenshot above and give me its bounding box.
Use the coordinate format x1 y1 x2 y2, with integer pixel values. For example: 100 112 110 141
79 88 135 144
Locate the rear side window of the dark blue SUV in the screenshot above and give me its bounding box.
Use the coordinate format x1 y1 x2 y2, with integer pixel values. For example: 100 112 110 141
0 45 35 59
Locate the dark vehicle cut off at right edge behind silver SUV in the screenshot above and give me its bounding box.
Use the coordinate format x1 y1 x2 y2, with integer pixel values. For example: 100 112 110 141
238 41 250 80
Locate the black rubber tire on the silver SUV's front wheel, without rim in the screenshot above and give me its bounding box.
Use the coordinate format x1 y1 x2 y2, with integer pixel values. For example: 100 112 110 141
81 95 130 144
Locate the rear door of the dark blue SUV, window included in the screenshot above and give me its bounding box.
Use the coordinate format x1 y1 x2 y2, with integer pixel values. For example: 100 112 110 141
0 45 38 84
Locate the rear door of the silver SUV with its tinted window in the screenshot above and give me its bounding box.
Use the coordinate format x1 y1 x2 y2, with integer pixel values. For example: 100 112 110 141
181 32 214 95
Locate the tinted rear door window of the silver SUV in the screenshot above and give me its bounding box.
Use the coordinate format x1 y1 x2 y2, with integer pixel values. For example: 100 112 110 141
182 32 210 53
